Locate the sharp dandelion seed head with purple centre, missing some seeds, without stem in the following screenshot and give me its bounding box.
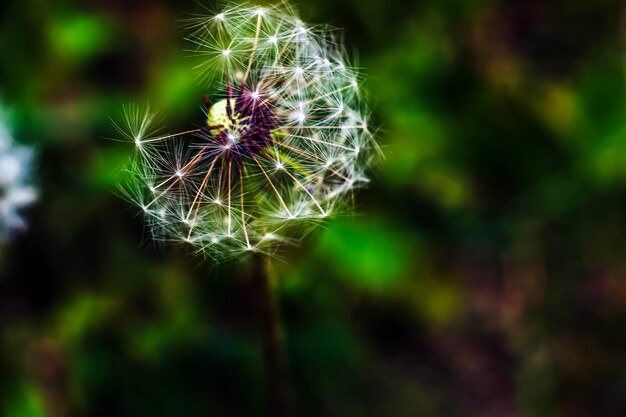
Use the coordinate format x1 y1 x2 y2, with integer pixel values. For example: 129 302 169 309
123 3 378 258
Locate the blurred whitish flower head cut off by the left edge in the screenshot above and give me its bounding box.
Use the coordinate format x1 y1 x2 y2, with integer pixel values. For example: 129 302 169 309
0 107 37 240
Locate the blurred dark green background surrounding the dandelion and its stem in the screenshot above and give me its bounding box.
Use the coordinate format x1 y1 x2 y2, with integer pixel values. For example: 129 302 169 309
0 0 626 417
